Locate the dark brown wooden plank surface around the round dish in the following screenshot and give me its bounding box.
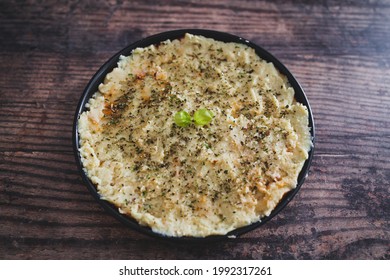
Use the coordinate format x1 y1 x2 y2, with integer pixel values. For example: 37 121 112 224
0 0 390 259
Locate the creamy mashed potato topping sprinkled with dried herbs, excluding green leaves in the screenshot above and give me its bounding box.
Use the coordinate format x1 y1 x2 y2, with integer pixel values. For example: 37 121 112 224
78 34 311 237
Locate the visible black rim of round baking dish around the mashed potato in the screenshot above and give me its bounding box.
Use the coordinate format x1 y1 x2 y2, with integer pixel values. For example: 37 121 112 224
72 29 315 242
